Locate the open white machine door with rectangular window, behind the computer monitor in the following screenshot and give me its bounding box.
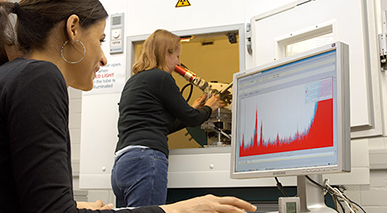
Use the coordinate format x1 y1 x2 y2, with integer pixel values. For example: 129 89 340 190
246 0 382 138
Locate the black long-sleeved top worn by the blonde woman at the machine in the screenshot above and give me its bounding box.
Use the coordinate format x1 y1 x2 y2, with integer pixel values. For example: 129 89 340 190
116 69 212 157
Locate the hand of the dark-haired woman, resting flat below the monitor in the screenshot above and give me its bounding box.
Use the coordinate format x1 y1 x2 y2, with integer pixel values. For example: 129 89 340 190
160 195 257 213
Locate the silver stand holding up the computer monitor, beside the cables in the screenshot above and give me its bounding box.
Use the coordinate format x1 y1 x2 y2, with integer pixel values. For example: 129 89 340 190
297 175 337 213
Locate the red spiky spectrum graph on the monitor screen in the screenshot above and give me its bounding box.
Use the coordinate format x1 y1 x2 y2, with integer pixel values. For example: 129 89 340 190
239 99 333 157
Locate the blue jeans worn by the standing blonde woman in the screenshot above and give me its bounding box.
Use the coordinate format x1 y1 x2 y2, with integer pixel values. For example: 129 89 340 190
111 148 168 207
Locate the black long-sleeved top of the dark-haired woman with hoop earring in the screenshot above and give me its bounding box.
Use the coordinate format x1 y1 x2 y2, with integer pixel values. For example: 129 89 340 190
0 58 163 213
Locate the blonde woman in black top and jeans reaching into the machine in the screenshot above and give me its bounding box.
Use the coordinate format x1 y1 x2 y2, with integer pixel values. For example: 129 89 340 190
111 29 224 206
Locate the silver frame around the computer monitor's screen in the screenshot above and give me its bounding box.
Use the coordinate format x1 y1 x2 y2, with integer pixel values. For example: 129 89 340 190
230 42 351 179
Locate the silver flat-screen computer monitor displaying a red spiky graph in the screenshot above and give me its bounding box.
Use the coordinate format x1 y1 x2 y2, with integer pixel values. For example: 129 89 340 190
231 42 351 211
